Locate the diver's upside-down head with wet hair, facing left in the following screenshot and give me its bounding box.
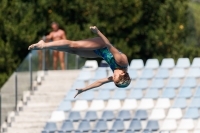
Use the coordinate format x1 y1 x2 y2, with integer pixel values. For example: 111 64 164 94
113 70 131 88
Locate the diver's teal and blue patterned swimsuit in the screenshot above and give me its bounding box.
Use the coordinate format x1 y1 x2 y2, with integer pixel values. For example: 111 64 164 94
94 47 127 72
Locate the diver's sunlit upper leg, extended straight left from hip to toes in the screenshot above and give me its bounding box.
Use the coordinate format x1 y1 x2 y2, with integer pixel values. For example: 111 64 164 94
28 37 106 50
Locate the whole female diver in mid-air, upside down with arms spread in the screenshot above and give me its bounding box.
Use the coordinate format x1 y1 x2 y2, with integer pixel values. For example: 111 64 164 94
29 26 131 97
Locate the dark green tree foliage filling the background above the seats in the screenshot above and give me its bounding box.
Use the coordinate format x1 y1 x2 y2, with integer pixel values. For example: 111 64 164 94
0 0 200 86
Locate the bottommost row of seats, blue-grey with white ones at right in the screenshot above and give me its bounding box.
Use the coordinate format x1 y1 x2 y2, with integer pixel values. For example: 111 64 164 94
43 119 200 133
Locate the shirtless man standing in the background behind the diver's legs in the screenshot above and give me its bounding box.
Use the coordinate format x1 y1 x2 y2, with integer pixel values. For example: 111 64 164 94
46 22 67 70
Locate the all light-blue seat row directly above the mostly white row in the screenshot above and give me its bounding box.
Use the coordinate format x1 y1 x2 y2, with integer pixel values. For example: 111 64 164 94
64 87 200 101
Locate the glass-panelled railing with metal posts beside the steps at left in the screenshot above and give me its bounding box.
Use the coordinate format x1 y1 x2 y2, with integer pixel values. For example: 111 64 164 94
0 50 85 125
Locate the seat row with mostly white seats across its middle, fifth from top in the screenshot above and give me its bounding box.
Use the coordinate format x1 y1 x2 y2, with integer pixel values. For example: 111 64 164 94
55 97 200 111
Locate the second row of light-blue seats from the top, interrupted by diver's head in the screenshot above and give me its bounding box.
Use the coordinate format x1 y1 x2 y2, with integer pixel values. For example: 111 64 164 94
78 68 200 80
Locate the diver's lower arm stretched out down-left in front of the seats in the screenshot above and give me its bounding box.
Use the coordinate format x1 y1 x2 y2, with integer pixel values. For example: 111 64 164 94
74 76 113 98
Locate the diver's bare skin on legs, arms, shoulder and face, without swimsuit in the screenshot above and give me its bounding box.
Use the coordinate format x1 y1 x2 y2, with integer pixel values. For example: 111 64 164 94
28 26 128 97
